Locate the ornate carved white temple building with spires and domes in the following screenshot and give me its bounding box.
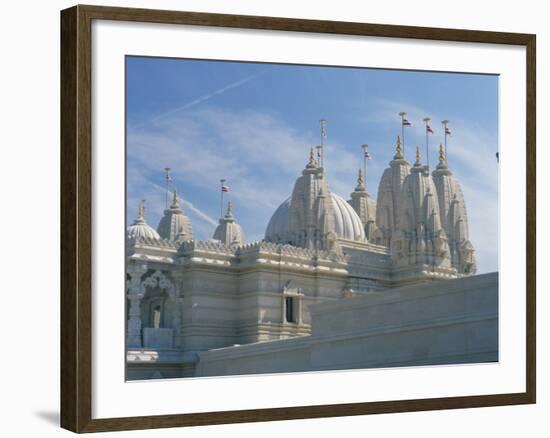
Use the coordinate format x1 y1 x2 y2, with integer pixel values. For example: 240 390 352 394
126 133 476 378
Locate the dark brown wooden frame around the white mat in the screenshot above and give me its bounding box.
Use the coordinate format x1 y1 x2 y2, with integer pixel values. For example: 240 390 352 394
61 6 536 433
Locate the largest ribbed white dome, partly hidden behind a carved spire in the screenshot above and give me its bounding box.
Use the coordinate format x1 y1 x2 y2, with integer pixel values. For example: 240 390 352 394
265 192 365 242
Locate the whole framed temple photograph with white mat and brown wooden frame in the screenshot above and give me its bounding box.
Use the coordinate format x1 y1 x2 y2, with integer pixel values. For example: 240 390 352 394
61 6 536 432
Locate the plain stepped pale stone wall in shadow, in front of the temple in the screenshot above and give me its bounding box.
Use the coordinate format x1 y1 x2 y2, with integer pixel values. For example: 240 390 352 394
195 273 498 376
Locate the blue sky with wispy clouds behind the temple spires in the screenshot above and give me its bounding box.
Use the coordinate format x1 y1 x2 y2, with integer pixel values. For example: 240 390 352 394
126 57 498 272
